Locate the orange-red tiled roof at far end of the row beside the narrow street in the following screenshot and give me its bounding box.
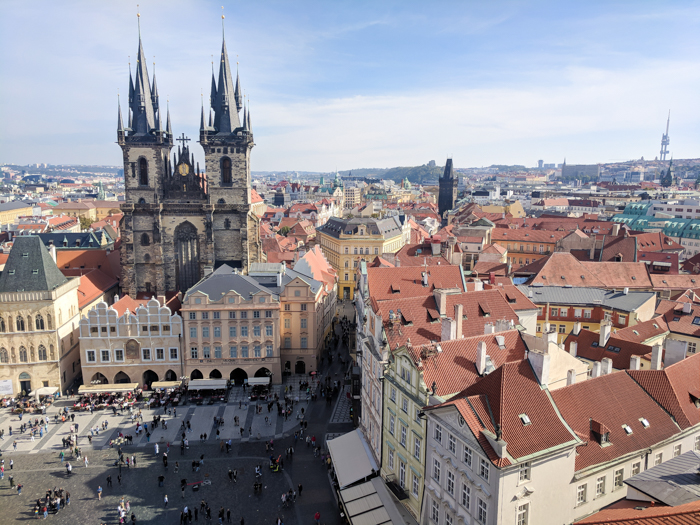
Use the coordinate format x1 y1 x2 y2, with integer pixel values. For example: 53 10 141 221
367 264 466 301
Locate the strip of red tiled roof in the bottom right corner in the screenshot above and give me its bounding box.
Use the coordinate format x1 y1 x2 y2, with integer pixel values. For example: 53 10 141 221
576 500 700 525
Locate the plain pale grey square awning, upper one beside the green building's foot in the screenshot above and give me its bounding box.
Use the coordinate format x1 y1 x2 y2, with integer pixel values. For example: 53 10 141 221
328 429 379 489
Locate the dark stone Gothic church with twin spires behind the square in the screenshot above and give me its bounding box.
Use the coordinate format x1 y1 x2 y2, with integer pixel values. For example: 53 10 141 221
117 28 265 297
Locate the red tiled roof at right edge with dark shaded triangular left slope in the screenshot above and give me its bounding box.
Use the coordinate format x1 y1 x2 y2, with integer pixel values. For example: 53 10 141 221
628 348 700 429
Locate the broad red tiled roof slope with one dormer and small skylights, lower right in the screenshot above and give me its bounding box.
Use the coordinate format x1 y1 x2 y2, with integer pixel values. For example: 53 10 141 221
551 373 678 471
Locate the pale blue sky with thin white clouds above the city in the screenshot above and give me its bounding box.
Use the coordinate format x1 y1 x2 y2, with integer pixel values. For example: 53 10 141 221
0 0 700 172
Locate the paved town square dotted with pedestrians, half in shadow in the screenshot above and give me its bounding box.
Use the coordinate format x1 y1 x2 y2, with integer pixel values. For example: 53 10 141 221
0 326 353 525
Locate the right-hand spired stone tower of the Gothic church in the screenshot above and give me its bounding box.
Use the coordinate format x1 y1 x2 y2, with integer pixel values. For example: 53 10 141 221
199 25 265 271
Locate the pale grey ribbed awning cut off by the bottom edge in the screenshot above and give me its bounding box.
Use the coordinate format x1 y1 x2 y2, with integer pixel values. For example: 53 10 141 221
340 477 418 525
